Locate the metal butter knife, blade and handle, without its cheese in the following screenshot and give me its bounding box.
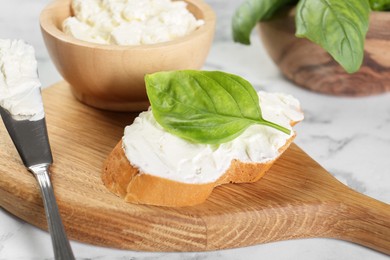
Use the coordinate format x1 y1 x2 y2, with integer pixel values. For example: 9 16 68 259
0 106 75 260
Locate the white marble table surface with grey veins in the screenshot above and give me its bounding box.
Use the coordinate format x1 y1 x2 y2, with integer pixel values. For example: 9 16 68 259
0 0 390 260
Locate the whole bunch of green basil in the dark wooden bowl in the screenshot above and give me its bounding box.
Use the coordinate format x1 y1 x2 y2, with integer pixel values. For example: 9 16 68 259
232 0 374 73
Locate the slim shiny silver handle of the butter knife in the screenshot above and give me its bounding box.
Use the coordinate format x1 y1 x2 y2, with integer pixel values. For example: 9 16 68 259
29 164 75 260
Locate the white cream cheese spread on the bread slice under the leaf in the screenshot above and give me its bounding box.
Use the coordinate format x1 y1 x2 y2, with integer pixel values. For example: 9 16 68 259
122 91 303 184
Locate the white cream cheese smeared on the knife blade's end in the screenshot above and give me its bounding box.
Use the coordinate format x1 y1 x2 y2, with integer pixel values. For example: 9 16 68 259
0 39 44 121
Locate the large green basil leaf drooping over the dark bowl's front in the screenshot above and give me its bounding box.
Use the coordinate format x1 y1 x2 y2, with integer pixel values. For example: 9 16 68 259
296 0 370 73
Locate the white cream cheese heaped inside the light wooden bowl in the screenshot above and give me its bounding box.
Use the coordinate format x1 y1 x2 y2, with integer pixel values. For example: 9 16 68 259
62 0 204 45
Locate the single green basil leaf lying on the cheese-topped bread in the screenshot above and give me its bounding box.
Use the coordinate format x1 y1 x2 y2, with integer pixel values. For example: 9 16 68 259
145 70 290 144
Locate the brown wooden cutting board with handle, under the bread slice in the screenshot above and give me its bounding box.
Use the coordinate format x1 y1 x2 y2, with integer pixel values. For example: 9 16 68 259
0 82 390 254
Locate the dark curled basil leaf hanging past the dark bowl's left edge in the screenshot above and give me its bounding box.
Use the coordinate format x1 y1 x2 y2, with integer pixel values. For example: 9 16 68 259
232 0 297 44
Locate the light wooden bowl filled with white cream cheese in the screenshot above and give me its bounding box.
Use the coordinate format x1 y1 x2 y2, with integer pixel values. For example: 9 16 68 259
40 0 216 111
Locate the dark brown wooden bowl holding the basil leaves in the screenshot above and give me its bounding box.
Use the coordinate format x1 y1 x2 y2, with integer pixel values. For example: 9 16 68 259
258 8 390 96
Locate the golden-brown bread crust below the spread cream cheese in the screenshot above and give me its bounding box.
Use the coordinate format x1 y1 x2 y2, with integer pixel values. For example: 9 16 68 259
102 134 295 207
